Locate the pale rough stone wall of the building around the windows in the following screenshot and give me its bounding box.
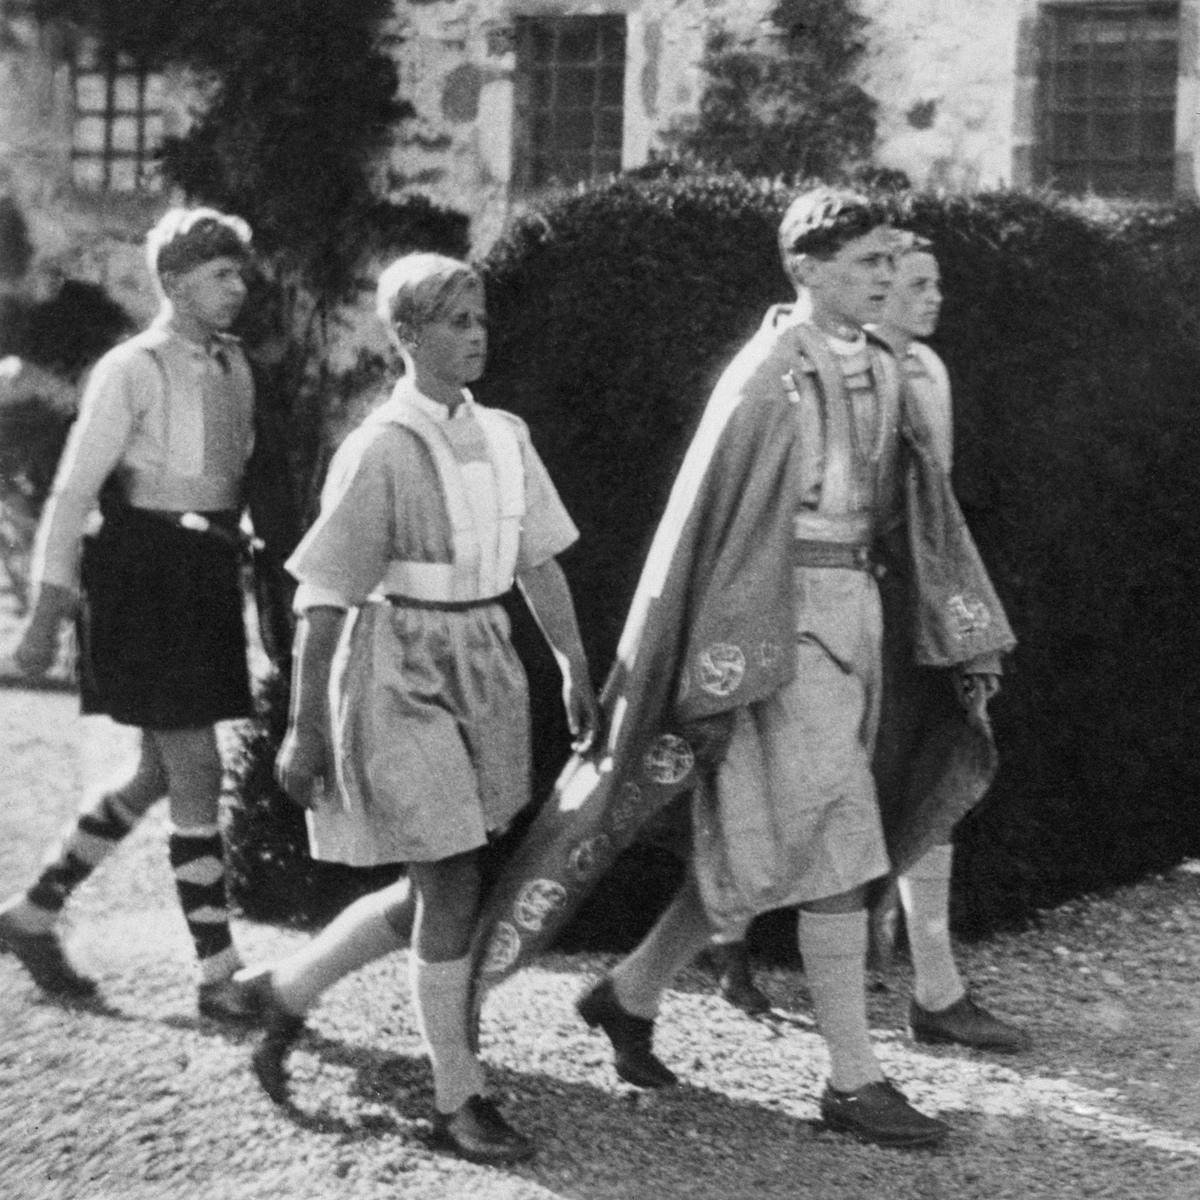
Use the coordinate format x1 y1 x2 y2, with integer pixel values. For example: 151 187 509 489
7 0 1200 364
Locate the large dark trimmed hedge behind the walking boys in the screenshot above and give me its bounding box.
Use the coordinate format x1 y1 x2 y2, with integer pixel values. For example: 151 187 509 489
225 175 1200 947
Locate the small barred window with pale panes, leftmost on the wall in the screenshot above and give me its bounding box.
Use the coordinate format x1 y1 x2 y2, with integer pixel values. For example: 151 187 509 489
71 38 163 192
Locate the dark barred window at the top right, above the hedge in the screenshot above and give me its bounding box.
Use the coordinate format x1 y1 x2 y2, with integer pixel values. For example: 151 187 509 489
1034 4 1180 199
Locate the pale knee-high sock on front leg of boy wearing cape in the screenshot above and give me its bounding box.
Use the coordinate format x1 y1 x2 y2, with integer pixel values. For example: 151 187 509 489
798 908 883 1092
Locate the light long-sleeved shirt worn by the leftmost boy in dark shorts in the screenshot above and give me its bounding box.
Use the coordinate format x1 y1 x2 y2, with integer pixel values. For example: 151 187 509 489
32 318 254 588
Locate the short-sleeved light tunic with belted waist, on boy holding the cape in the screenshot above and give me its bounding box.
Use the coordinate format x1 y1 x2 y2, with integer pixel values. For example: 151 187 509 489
288 382 578 866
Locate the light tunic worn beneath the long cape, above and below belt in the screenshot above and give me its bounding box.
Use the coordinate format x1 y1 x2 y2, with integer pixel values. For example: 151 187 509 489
694 324 899 912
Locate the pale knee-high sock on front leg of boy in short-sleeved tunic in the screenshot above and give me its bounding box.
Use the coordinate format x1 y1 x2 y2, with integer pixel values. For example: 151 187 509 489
408 950 487 1112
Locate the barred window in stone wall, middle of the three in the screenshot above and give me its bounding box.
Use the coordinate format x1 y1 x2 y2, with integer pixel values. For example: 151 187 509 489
514 16 625 188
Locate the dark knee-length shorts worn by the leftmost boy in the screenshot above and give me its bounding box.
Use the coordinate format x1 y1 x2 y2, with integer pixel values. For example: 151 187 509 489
79 509 251 730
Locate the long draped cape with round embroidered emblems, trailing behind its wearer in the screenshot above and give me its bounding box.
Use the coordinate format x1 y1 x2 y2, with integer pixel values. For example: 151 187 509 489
472 320 1012 1014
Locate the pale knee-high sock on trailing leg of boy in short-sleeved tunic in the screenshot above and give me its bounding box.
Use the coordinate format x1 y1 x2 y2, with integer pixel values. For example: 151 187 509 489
271 881 412 1016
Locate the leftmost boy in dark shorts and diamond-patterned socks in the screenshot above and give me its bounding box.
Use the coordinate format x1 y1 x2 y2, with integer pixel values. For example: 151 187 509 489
0 208 272 1020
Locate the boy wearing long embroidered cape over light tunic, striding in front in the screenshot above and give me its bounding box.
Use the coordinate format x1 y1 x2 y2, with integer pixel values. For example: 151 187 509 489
476 188 1014 1146
